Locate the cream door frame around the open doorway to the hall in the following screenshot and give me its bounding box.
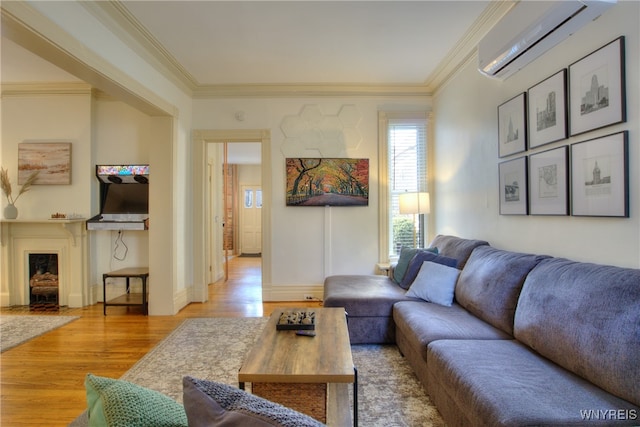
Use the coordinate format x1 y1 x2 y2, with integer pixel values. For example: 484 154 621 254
191 129 271 302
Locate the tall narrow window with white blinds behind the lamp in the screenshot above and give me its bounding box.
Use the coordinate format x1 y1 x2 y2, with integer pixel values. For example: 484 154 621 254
380 113 428 260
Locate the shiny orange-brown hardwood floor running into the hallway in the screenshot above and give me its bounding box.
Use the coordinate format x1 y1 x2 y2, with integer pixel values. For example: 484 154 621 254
0 257 320 426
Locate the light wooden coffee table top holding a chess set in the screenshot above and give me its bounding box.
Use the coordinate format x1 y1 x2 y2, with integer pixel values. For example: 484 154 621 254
238 307 355 383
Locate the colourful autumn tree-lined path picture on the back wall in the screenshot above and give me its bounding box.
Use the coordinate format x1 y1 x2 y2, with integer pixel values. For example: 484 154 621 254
286 158 369 206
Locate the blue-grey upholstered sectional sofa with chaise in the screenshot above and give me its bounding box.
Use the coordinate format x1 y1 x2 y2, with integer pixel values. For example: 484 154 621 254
324 236 640 426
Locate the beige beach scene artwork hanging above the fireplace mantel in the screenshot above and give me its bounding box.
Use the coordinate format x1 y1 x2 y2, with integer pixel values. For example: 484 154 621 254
18 142 71 185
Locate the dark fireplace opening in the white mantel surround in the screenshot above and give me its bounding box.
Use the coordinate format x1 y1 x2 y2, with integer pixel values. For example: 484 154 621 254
29 254 60 311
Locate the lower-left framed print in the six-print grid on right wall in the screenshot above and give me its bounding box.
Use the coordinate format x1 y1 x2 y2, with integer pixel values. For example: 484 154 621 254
498 156 529 215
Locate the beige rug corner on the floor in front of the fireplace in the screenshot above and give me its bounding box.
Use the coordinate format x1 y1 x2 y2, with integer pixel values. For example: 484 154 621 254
0 314 80 352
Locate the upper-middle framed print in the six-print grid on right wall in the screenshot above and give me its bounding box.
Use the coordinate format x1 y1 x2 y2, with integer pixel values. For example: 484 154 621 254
527 68 567 148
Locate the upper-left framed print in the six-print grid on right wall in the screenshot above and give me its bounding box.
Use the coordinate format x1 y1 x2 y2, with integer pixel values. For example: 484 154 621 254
498 92 527 157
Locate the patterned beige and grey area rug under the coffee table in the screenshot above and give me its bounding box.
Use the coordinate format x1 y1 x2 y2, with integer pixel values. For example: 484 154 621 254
112 318 444 427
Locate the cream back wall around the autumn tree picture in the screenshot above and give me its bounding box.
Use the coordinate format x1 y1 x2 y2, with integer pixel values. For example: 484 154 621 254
193 97 430 299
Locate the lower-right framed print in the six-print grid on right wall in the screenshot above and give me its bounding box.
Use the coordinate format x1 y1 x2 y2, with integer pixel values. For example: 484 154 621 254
571 131 629 217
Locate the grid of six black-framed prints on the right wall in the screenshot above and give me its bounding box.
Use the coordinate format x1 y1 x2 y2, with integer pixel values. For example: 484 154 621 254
498 36 629 217
